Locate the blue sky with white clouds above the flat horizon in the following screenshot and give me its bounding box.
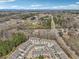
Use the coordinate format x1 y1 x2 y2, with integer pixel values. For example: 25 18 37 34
0 0 79 10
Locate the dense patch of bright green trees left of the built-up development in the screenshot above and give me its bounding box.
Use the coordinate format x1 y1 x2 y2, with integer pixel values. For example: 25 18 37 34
0 33 27 57
